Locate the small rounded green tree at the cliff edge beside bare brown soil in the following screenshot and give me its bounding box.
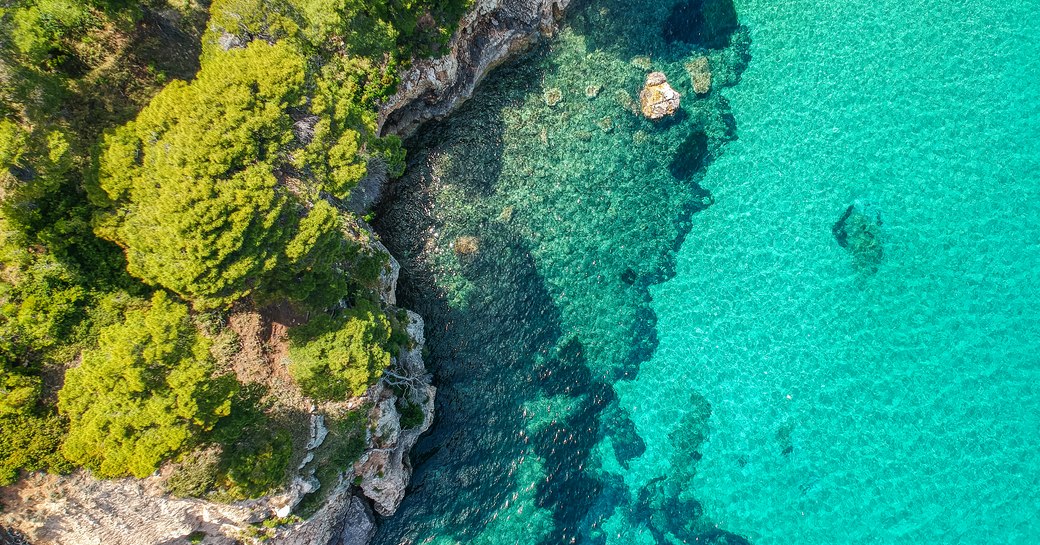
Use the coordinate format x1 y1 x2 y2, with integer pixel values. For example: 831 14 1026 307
289 303 392 399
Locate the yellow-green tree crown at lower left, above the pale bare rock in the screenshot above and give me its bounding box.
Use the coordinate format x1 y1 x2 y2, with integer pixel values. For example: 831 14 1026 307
58 291 236 477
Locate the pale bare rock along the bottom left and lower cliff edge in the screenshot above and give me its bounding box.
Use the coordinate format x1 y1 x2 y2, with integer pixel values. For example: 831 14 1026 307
0 241 436 545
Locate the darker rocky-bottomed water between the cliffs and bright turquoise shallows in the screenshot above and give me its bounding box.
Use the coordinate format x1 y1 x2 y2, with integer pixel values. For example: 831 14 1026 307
374 1 749 543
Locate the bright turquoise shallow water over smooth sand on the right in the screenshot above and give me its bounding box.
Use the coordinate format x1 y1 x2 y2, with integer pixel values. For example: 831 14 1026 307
621 0 1040 544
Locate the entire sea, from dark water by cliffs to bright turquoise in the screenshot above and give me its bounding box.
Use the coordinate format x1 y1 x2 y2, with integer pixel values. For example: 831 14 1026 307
376 0 1040 545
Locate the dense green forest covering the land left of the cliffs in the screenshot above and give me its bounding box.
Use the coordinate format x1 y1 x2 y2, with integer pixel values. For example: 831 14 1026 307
0 0 467 499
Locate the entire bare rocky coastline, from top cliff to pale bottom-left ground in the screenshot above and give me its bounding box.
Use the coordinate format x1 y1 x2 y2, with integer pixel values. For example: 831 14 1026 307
0 0 570 545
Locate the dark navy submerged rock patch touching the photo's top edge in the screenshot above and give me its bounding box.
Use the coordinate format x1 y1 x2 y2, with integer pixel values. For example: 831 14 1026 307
662 0 740 49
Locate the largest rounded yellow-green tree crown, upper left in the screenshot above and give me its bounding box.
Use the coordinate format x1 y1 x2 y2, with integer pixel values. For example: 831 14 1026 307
98 42 304 308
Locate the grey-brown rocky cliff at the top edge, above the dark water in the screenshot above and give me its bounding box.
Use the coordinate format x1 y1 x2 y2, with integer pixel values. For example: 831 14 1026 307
379 0 571 136
